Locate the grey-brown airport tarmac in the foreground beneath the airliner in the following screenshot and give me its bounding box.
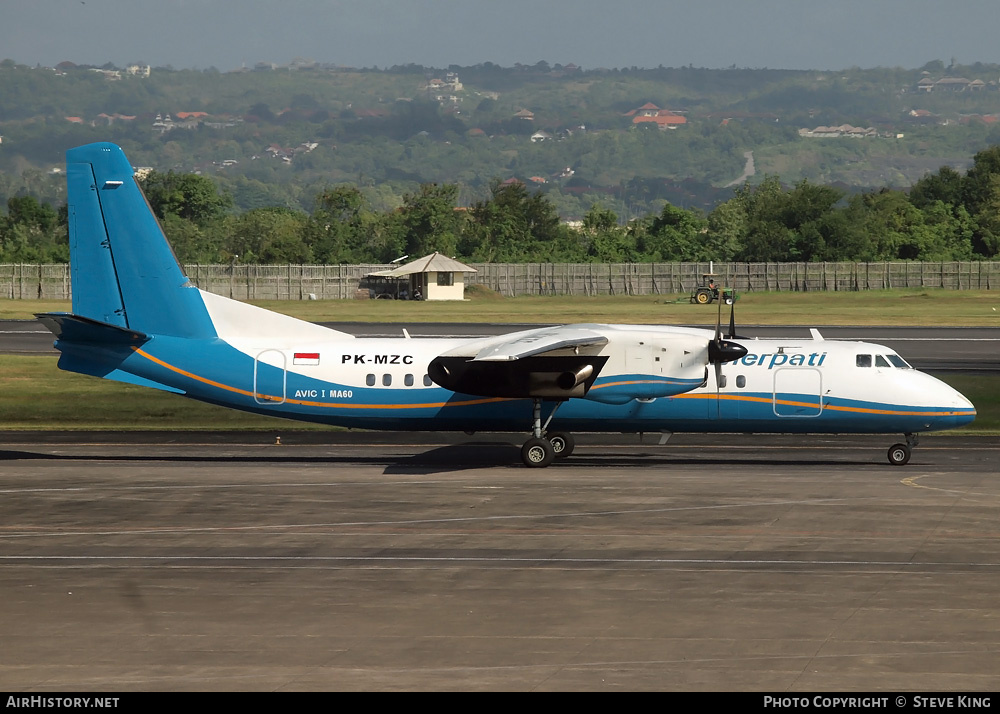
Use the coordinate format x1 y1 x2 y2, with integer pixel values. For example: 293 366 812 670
0 432 1000 694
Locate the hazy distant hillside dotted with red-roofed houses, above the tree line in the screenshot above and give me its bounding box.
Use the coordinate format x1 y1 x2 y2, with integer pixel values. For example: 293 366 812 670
0 59 1000 220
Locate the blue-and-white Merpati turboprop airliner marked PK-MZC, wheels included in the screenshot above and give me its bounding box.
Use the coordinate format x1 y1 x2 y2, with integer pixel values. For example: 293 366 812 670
38 143 976 467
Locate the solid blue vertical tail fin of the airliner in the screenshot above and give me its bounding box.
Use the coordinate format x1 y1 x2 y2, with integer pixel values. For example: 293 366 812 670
66 143 216 338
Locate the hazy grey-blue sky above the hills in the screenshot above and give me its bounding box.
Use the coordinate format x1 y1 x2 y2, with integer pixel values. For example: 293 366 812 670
0 0 1000 71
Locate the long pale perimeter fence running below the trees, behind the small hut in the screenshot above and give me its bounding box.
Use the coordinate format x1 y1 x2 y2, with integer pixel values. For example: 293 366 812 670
0 261 1000 300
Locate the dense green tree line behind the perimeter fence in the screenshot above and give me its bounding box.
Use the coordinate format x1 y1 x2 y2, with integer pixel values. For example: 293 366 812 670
0 145 1000 264
